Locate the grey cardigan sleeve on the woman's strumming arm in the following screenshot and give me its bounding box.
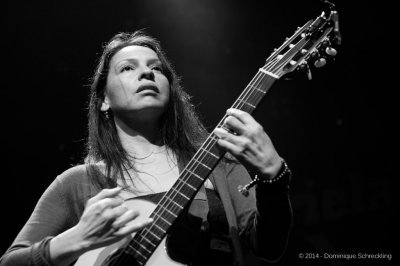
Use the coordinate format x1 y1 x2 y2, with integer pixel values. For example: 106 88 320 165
0 165 88 266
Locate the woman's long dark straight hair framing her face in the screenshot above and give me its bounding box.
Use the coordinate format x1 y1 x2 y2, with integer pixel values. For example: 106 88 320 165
85 30 207 188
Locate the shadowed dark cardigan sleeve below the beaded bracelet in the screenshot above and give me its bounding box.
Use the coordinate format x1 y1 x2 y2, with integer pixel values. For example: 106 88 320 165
222 160 292 261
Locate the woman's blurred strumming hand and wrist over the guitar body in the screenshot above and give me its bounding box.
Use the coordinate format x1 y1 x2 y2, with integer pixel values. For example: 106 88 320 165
50 188 152 265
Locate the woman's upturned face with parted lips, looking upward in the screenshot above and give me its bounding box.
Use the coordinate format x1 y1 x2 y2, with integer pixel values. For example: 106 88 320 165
101 46 170 119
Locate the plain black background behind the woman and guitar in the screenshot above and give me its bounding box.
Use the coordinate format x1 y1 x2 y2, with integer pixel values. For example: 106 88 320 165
0 0 398 265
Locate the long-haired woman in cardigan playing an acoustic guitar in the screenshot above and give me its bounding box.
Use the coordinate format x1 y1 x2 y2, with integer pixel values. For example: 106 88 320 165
0 31 292 266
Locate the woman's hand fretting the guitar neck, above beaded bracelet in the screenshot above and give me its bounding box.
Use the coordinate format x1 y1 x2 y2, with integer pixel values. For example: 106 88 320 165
214 108 282 179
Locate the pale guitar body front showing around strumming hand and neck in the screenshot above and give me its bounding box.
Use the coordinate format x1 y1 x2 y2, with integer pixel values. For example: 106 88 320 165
74 199 184 266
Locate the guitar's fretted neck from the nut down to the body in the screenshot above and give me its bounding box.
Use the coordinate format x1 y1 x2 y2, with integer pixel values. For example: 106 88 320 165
126 69 278 265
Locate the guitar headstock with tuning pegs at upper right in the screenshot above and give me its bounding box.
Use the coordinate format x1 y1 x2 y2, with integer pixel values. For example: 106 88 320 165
262 1 341 79
